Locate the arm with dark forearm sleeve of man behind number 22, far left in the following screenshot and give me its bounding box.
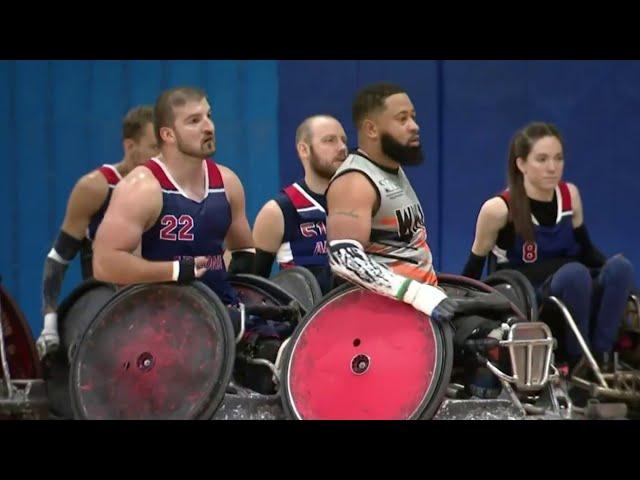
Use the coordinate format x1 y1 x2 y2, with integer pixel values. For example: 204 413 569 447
42 172 109 315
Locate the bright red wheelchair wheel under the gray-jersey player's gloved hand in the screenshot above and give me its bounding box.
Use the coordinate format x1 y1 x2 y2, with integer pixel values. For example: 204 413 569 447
281 285 453 420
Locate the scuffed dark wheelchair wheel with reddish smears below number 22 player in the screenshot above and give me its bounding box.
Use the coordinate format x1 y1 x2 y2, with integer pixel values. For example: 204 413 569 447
70 282 235 419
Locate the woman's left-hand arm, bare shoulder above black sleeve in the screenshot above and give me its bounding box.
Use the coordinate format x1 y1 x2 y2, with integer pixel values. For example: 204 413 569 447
462 197 509 279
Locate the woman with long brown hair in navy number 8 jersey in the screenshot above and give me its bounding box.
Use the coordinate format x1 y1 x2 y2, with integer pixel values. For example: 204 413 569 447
463 123 634 368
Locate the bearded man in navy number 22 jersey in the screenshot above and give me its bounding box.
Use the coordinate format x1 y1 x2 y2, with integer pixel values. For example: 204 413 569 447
93 87 255 322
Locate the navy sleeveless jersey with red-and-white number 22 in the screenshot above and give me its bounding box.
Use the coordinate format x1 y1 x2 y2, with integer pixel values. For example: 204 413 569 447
142 158 237 305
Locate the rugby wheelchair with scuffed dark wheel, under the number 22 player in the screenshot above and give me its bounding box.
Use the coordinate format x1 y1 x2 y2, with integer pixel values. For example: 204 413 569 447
54 269 321 419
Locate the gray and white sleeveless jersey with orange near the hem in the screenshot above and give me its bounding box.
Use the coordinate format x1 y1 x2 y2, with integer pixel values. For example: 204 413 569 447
329 153 438 285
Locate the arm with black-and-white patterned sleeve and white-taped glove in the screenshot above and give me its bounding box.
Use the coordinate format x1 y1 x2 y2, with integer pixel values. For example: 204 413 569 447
327 172 455 320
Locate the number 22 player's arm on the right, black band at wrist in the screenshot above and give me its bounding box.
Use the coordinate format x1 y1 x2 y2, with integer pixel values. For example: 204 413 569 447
218 165 255 273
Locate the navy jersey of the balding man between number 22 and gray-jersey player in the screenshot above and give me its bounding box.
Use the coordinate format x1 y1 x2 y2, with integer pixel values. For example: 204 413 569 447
275 180 330 291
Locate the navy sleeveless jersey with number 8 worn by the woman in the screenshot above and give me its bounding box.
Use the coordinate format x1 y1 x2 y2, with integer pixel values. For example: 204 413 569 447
492 182 581 269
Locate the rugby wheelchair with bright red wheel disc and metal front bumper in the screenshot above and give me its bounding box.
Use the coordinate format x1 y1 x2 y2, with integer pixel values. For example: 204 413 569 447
281 274 570 419
